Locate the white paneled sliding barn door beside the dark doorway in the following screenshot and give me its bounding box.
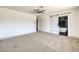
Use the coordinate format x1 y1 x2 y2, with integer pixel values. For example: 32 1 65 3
51 16 59 34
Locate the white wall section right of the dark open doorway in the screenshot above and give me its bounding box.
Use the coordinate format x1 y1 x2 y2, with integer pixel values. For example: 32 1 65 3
68 8 79 38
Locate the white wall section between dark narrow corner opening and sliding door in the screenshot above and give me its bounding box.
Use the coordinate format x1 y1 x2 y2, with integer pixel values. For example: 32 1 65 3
38 15 50 32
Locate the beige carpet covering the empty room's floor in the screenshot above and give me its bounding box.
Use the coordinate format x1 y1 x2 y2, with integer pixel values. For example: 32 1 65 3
0 32 79 52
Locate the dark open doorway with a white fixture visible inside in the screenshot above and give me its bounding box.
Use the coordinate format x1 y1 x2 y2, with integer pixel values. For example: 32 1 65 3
58 16 68 36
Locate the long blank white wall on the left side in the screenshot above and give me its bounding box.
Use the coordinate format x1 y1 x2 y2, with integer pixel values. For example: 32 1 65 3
0 8 36 39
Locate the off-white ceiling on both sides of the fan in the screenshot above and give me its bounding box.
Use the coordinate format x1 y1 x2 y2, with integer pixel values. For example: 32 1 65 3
2 6 76 14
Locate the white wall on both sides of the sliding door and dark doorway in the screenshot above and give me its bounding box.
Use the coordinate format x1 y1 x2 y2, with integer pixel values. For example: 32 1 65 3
39 8 79 38
